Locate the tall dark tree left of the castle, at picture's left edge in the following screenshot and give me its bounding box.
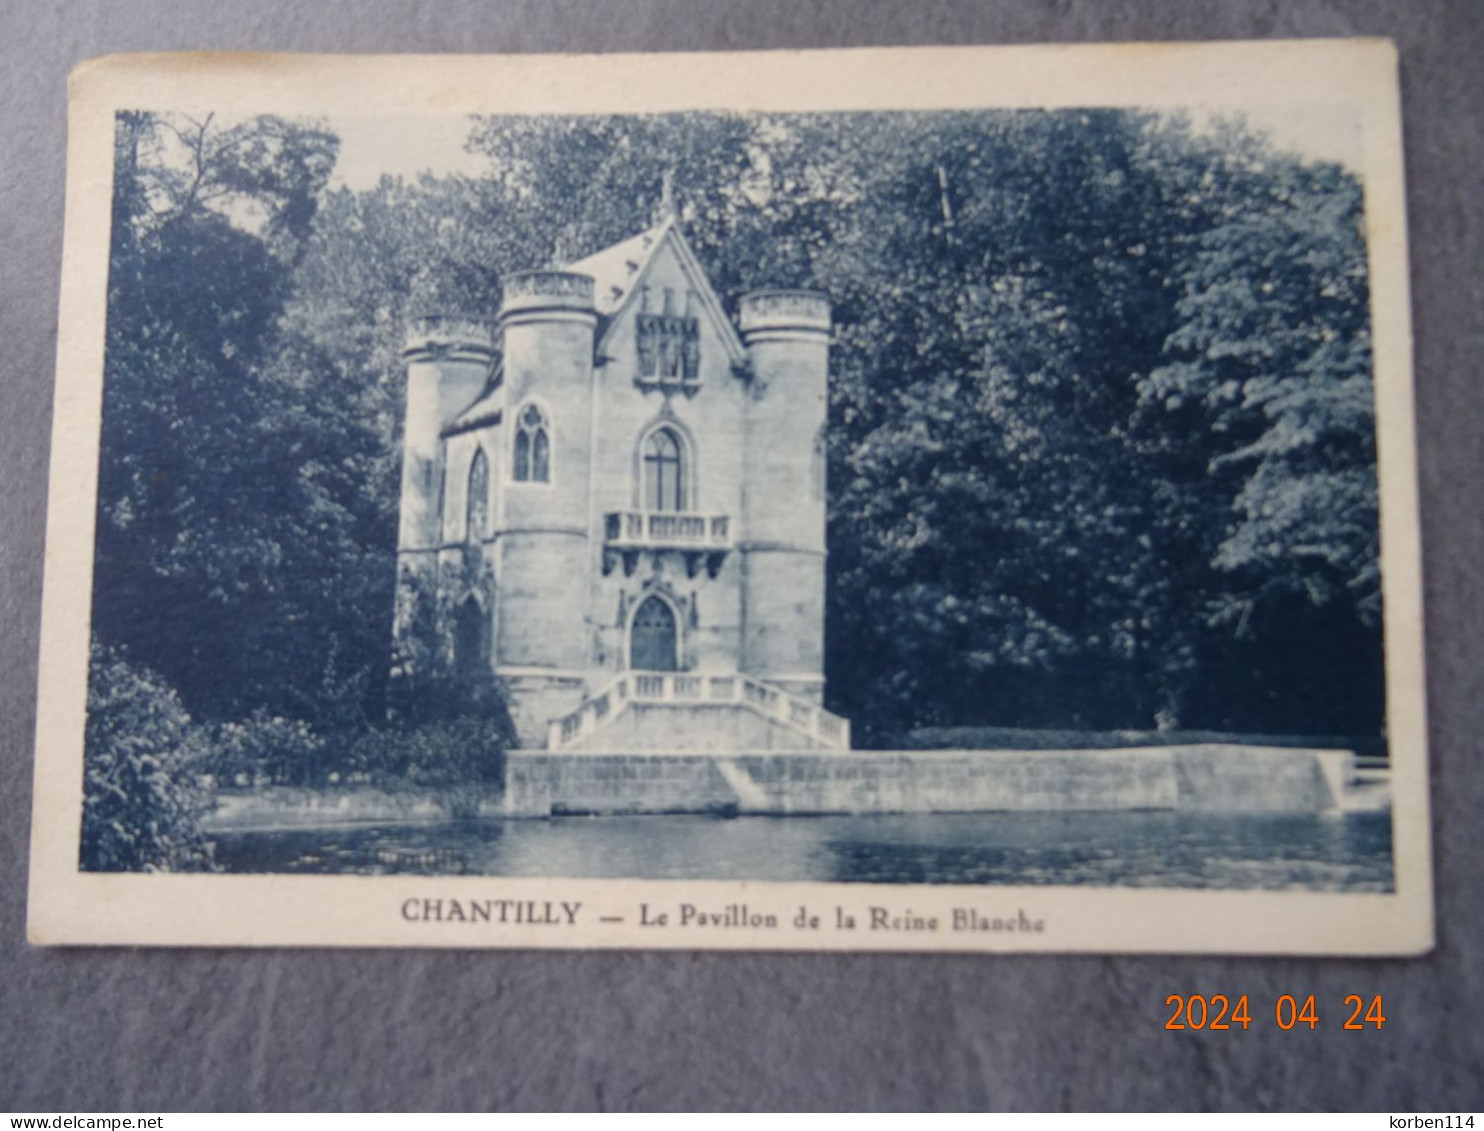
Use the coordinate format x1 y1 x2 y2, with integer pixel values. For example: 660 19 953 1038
93 114 406 726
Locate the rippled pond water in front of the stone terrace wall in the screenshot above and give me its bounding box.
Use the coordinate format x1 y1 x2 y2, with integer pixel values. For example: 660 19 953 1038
215 812 1393 892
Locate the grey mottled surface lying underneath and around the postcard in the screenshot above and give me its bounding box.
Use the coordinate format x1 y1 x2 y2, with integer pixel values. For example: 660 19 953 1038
0 0 1484 1112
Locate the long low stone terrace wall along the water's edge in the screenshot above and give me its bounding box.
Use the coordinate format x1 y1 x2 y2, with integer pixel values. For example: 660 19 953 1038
506 745 1350 816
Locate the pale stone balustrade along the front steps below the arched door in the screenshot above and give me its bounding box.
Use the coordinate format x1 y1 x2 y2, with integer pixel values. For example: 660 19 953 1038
546 671 850 753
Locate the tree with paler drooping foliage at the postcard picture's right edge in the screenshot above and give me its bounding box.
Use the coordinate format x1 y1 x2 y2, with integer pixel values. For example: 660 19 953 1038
1141 123 1383 730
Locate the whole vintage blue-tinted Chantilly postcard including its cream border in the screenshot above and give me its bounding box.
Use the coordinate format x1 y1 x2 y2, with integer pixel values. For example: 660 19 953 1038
30 40 1434 954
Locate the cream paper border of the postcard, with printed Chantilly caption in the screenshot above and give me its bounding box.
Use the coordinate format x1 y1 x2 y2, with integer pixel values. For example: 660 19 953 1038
27 40 1434 954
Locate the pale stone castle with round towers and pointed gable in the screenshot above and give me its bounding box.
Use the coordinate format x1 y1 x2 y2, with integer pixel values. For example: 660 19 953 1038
396 221 849 750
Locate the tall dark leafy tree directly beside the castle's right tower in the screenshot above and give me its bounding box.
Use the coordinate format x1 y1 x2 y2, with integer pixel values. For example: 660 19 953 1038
807 111 1178 726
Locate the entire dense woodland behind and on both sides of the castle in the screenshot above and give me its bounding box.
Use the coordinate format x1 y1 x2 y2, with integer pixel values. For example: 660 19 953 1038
84 110 1383 795
